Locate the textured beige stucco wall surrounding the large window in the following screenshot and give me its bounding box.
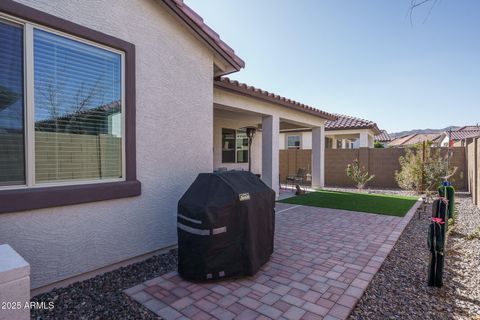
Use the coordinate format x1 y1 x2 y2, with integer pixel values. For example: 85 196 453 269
0 0 217 288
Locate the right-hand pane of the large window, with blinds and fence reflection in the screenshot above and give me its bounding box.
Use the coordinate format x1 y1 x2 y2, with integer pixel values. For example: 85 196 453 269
34 29 123 183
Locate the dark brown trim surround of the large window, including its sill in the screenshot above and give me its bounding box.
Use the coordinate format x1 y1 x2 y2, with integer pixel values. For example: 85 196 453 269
0 0 141 213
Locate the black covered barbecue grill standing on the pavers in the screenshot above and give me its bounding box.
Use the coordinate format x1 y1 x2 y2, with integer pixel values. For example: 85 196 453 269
177 171 275 281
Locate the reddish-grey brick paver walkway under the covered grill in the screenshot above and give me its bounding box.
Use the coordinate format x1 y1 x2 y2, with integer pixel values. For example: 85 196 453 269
125 204 420 319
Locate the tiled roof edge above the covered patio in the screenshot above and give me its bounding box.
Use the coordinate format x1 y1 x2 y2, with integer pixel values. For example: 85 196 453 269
214 77 336 120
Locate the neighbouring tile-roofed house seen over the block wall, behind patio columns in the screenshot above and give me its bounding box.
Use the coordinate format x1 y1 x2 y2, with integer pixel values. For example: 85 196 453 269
280 114 380 149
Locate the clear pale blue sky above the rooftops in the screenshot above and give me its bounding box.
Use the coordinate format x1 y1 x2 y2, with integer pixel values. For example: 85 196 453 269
185 0 480 132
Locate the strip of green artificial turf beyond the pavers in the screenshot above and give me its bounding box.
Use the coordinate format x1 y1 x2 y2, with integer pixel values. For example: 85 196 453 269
279 190 417 217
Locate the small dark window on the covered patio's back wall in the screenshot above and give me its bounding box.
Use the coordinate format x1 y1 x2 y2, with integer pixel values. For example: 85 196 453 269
222 129 248 163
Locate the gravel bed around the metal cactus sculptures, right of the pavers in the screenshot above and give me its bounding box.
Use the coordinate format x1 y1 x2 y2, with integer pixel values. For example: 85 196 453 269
350 194 480 320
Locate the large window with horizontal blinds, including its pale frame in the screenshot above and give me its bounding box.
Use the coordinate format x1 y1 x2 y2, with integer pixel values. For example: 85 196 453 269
0 16 125 187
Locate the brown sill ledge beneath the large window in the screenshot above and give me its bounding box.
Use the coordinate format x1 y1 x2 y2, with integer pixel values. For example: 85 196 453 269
0 180 141 213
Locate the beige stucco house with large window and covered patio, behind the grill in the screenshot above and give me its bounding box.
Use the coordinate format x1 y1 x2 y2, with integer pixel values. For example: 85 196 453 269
0 0 334 292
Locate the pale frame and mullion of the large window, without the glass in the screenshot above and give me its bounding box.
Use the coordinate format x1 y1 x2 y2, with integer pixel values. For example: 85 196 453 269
0 13 126 190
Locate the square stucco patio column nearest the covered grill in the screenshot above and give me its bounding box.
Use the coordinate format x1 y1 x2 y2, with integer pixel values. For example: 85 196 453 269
262 115 280 197
